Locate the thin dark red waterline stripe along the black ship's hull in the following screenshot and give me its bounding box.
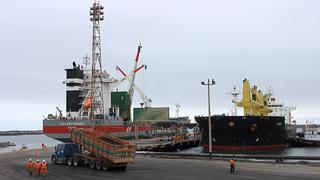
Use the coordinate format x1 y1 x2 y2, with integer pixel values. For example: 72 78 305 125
202 144 286 151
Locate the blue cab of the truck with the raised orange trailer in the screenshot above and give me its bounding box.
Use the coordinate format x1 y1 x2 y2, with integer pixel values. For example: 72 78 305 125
51 143 80 164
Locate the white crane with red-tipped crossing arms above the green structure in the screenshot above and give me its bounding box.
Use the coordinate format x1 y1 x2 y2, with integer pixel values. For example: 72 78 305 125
117 43 152 107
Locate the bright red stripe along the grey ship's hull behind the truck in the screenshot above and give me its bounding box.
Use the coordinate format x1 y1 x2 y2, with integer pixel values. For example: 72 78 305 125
43 125 149 134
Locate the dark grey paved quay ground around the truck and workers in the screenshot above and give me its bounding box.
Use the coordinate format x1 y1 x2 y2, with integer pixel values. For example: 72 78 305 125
0 148 320 180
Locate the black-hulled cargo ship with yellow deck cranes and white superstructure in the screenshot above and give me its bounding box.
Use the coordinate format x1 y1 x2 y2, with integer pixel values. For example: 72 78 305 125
195 79 295 152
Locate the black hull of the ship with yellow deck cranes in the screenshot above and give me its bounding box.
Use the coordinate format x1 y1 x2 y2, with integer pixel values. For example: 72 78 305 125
195 116 286 152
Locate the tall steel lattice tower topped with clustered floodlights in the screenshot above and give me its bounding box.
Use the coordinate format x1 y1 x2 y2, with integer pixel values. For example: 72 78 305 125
89 1 105 119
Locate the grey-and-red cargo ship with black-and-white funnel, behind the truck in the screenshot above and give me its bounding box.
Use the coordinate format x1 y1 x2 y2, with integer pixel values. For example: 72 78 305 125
43 2 185 142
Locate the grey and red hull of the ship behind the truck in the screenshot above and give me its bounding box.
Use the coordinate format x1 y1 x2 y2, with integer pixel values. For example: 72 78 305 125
43 119 151 142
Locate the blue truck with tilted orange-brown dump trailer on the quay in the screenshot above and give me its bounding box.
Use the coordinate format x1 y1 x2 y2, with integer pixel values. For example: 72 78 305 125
51 129 136 170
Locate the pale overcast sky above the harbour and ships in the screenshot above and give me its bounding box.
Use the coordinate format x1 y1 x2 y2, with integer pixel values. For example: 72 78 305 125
0 0 320 130
